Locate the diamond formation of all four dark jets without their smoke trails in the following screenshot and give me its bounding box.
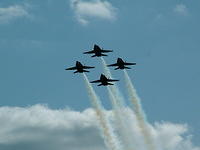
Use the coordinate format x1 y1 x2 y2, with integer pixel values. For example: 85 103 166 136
65 44 136 86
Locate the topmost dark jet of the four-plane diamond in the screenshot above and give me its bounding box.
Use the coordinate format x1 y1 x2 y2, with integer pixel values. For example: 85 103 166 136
83 44 113 57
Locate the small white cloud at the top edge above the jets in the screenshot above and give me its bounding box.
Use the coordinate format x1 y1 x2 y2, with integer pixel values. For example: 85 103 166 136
71 0 116 25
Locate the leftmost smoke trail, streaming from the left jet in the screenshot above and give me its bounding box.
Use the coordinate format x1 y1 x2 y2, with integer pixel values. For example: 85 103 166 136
83 74 121 150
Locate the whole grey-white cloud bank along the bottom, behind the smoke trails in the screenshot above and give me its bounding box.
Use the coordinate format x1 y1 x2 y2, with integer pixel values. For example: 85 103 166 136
0 105 200 150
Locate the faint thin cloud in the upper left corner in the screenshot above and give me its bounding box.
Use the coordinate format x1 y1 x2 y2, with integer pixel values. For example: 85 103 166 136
0 5 29 24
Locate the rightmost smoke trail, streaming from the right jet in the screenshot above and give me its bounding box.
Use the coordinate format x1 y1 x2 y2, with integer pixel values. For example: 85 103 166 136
124 70 156 150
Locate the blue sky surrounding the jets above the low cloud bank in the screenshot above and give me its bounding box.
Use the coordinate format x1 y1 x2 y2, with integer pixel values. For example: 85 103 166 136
0 0 200 150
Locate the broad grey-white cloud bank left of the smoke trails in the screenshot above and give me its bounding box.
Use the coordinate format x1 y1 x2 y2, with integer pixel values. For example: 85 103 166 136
0 105 105 150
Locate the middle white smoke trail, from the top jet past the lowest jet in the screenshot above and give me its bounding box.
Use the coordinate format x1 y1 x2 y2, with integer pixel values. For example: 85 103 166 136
101 57 134 150
